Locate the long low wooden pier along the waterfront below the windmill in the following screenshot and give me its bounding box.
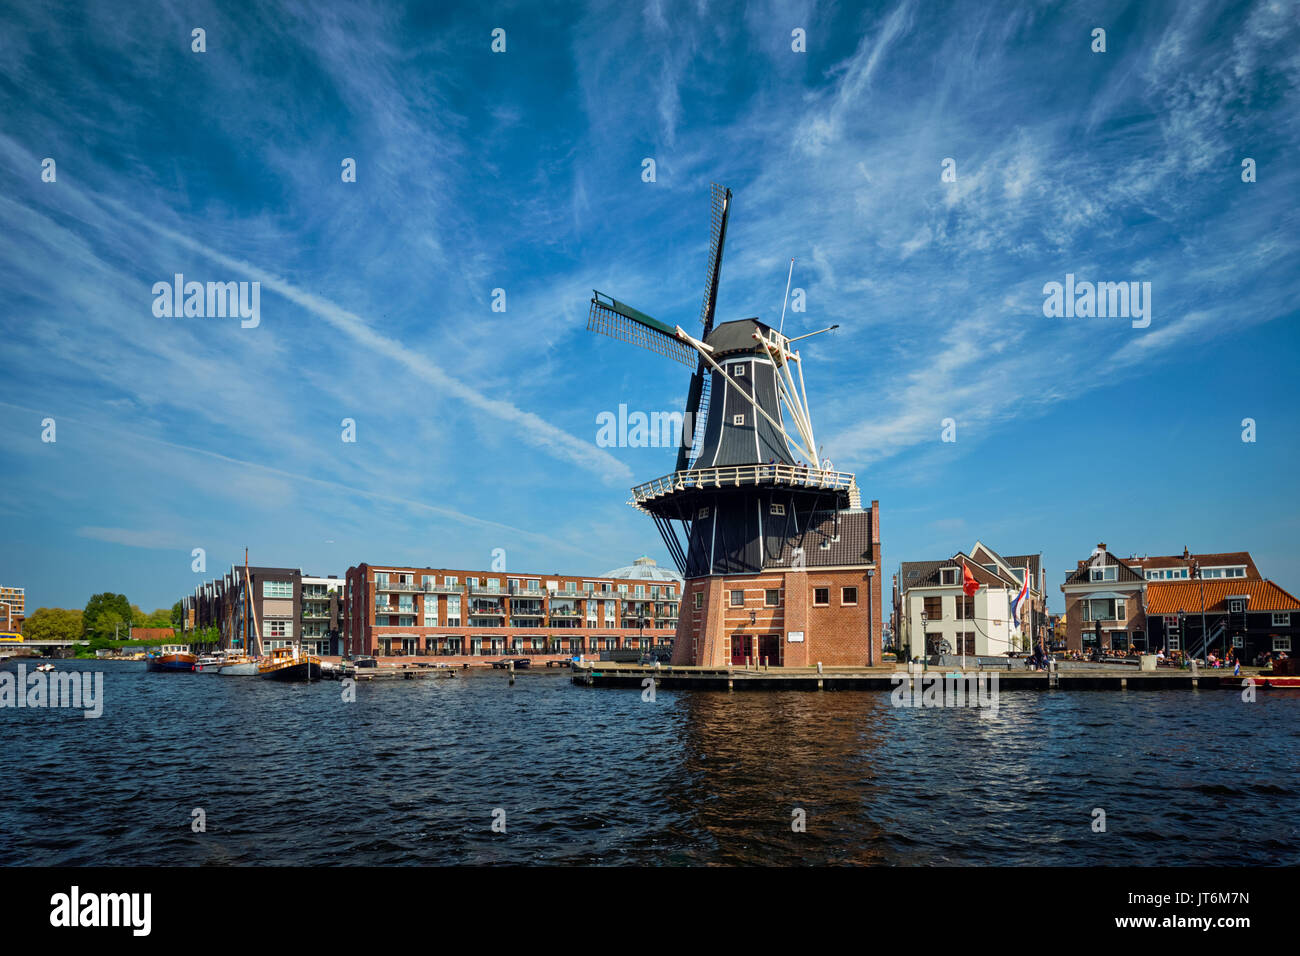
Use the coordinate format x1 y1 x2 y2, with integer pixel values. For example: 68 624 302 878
572 661 1268 692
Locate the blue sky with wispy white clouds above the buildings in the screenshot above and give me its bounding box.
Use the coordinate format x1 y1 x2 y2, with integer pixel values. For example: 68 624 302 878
0 1 1300 610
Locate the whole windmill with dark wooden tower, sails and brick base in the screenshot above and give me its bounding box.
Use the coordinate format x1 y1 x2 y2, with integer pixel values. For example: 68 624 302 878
588 185 880 666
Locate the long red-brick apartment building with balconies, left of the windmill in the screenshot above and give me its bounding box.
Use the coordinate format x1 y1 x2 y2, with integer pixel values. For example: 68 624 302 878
342 558 681 657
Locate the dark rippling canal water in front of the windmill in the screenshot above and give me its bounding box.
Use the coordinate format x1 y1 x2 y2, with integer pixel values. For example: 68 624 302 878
0 662 1300 865
